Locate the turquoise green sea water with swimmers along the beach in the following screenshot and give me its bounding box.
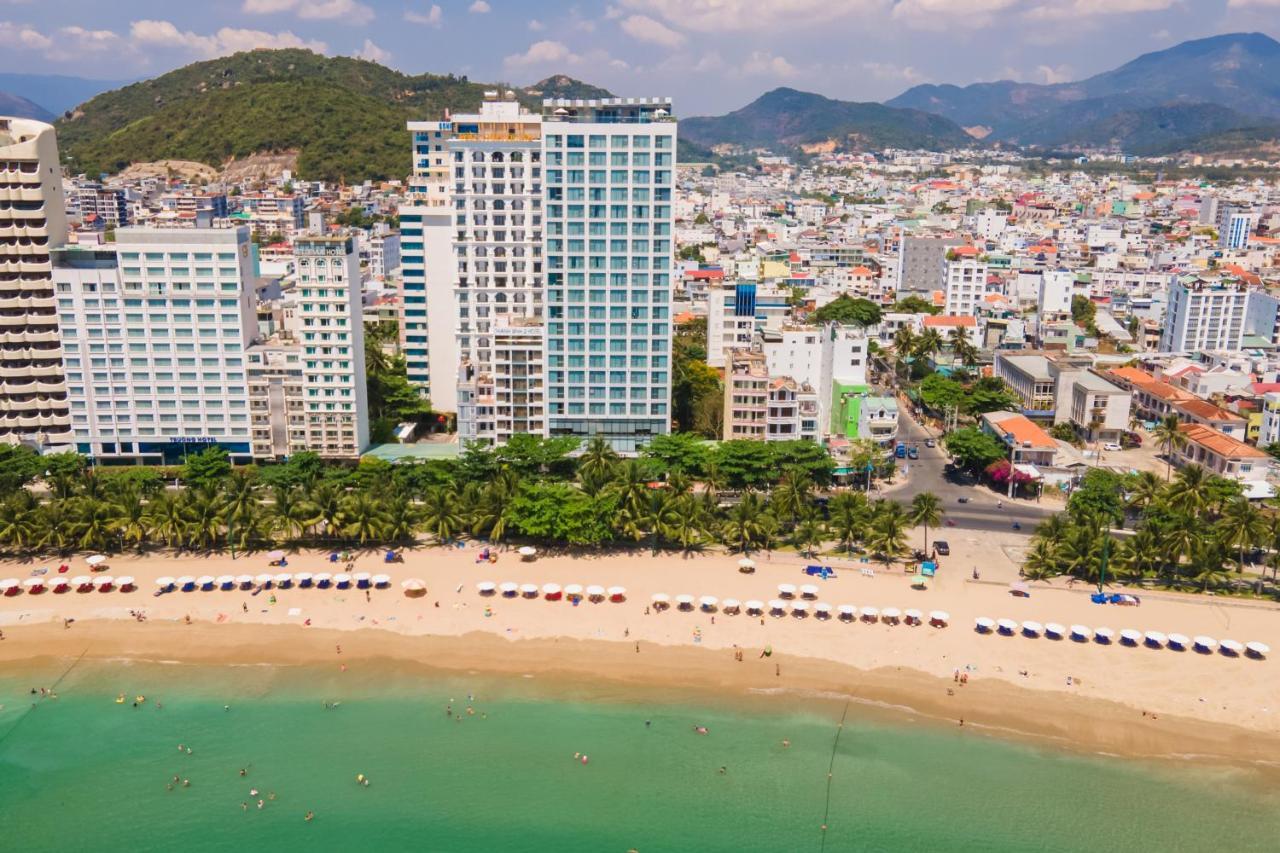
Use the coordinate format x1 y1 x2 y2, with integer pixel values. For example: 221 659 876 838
0 661 1280 853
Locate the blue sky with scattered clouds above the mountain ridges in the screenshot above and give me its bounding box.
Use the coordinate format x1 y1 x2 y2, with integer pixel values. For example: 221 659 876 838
0 0 1280 115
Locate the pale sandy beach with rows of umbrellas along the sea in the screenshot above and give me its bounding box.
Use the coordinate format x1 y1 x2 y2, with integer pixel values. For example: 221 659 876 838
0 530 1280 763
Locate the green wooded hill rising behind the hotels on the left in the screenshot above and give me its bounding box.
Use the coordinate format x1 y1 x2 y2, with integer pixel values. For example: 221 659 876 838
58 50 535 182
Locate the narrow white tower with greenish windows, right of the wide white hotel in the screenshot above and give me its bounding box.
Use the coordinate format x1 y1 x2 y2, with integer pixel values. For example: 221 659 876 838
294 236 369 459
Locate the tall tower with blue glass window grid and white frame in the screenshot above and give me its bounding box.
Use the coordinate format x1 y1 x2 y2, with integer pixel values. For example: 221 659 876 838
543 99 676 452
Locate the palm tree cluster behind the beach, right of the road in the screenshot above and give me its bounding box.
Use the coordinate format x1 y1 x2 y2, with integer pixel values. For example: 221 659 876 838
1023 465 1280 590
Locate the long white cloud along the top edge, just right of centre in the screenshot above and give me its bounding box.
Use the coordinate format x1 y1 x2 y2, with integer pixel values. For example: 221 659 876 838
621 0 885 33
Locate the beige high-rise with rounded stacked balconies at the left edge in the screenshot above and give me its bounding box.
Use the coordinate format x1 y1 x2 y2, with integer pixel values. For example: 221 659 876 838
0 118 72 451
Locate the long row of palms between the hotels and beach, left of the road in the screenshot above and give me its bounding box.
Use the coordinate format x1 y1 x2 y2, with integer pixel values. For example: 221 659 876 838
0 455 942 562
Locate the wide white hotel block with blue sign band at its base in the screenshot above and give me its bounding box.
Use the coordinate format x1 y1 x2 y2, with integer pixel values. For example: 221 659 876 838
54 227 257 465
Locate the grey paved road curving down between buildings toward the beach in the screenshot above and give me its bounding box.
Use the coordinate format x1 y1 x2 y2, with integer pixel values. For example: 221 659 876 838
886 410 1057 538
